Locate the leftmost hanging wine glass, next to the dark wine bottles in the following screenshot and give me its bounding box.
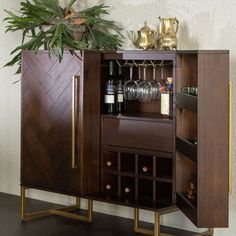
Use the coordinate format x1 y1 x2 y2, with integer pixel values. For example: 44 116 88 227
124 66 138 100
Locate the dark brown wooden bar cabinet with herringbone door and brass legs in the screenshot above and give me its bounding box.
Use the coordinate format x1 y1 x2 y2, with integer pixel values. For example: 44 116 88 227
21 50 230 235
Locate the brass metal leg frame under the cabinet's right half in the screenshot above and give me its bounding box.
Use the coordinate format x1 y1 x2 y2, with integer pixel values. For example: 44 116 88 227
134 208 214 236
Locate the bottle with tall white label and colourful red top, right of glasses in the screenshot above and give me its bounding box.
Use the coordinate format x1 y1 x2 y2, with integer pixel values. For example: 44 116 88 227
161 77 173 118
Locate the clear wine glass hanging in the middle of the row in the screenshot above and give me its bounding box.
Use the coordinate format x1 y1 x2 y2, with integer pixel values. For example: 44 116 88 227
138 65 152 102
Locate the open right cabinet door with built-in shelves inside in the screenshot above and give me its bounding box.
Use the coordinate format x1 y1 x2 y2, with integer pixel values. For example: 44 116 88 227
176 51 229 228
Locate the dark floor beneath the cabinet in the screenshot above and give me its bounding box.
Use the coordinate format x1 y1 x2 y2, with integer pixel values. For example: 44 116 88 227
0 193 193 236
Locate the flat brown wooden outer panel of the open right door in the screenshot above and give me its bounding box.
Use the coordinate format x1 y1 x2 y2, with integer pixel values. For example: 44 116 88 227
198 53 229 227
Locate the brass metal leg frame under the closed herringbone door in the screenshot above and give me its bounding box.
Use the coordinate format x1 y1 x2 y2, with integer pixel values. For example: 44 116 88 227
20 186 93 223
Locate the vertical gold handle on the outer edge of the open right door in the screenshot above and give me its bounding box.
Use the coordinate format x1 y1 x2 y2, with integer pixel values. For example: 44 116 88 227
229 81 233 194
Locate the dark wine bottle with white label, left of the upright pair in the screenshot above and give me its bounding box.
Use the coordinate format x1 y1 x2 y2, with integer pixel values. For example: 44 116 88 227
104 61 116 114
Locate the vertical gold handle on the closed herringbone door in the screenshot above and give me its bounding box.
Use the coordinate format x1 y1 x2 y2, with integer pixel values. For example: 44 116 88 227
71 76 79 169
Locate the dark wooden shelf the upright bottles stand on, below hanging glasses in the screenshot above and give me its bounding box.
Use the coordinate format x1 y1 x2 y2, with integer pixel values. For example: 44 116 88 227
102 112 173 123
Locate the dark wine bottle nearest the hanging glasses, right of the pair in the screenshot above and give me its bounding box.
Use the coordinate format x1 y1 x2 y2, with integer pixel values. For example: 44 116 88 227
116 66 125 113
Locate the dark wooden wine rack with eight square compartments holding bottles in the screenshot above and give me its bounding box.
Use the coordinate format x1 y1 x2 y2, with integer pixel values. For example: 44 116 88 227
101 146 173 205
